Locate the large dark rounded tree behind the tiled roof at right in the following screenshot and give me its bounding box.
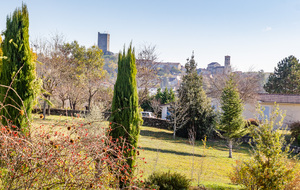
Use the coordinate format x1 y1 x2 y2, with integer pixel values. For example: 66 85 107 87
264 55 300 94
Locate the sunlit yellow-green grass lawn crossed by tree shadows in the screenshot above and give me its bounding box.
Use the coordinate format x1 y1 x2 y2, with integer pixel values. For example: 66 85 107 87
33 115 249 189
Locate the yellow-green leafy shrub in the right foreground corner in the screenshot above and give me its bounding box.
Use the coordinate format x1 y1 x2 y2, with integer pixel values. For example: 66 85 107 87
232 106 295 190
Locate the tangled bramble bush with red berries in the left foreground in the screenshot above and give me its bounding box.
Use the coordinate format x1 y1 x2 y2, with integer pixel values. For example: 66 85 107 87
0 117 146 189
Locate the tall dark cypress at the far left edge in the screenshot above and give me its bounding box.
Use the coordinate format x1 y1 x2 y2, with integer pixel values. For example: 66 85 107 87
0 4 36 132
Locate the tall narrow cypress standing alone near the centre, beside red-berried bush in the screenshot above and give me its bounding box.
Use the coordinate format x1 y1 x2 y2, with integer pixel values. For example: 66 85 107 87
110 45 142 173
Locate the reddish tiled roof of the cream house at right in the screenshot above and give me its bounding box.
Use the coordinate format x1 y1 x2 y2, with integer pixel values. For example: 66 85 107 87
258 94 300 104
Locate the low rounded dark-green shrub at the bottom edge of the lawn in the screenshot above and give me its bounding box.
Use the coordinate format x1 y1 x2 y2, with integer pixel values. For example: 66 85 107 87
146 171 191 190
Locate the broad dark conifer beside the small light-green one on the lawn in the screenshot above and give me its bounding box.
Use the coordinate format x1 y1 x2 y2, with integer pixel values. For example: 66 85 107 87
177 52 215 139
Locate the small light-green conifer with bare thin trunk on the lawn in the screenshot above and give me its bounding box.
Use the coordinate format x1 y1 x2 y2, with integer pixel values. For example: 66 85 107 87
219 74 246 158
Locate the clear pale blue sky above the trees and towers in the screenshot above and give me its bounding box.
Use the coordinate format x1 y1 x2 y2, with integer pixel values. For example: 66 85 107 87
0 0 300 72
